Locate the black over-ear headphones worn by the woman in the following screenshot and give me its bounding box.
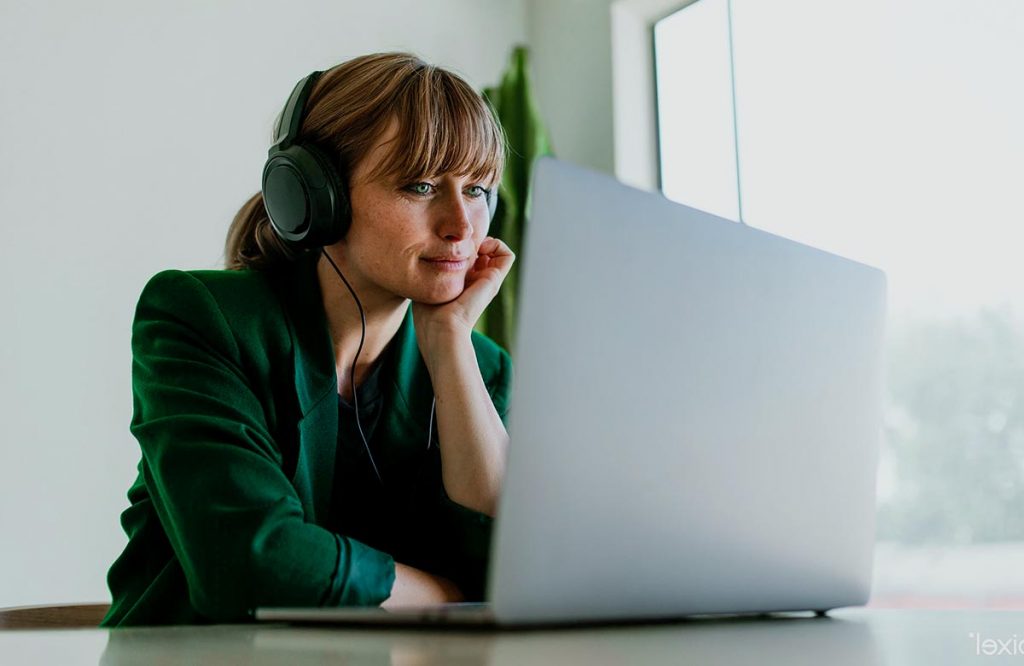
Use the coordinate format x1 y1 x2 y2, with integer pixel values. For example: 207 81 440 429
262 72 498 249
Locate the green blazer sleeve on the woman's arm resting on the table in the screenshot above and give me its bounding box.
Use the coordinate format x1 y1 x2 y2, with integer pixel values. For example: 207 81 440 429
131 270 394 622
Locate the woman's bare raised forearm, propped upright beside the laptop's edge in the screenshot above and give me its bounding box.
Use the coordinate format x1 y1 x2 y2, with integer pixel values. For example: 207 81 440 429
419 334 509 516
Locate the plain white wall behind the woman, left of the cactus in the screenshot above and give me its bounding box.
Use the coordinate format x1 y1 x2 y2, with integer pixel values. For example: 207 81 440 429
0 0 528 607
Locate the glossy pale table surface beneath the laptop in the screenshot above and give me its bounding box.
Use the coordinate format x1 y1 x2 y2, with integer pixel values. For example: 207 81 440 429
0 609 1024 666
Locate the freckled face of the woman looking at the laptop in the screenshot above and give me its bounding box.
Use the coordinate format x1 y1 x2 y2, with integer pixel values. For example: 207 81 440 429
338 124 492 304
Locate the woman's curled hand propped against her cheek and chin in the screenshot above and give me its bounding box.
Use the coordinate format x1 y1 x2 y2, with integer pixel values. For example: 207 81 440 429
413 236 515 358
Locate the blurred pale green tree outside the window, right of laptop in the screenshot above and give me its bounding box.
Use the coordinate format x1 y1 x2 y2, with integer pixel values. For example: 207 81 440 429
878 306 1024 545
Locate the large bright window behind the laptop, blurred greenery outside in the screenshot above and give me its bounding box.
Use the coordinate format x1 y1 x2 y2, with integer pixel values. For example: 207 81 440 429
654 0 1024 608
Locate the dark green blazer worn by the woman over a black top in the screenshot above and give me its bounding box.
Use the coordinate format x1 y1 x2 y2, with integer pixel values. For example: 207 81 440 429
102 254 512 626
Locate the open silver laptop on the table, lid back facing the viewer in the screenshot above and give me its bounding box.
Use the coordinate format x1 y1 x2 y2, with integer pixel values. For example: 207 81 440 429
256 158 886 625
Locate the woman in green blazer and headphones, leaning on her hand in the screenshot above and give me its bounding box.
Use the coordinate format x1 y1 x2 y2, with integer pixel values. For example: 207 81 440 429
103 53 514 626
